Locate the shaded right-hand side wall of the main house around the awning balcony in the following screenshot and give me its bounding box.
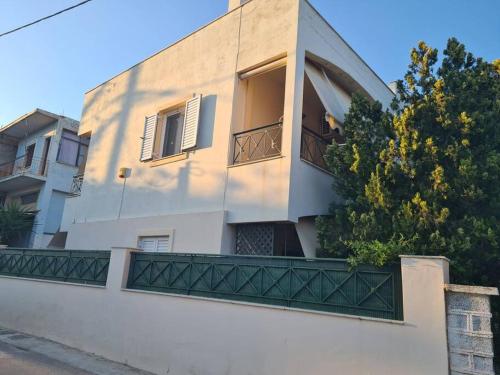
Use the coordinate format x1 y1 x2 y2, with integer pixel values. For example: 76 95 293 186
289 0 393 222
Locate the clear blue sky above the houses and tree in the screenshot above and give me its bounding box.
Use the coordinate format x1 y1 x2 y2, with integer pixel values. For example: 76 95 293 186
0 0 500 126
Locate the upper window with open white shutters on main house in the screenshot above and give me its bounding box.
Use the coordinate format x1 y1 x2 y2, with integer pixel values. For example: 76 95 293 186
140 95 201 161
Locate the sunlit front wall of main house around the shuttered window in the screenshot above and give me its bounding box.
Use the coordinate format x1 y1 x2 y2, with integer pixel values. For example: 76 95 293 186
63 0 298 252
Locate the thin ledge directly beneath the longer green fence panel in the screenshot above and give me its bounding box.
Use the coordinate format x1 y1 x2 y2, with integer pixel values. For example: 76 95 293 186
121 288 407 326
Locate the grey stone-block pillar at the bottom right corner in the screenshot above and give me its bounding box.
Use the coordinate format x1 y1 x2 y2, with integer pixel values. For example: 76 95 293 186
446 284 498 375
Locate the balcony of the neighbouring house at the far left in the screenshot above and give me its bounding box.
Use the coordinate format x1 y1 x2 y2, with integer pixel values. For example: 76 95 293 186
0 155 49 191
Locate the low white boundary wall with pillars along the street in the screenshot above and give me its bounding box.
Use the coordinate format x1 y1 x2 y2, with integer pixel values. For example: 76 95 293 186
0 253 448 375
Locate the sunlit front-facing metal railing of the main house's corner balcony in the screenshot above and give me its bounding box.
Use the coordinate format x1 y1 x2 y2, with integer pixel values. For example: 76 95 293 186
233 122 283 164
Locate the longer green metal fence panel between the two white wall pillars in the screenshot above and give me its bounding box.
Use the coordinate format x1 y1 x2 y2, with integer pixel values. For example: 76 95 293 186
127 252 403 320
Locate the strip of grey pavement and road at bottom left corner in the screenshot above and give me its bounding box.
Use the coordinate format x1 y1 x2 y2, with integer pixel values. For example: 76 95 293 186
0 327 153 375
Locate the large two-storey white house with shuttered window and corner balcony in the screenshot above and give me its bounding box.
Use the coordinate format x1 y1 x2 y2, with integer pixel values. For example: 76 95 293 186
62 0 393 256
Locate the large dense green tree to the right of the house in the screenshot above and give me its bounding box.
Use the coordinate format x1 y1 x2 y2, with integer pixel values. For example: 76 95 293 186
317 39 500 286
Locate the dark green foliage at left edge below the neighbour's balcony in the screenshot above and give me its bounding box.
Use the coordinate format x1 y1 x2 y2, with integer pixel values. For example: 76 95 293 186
0 203 36 244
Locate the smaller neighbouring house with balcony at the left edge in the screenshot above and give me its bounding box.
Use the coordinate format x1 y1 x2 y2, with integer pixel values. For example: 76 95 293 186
0 109 88 248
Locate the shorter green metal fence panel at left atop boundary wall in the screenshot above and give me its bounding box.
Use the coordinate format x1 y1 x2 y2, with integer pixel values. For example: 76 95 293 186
0 249 110 285
